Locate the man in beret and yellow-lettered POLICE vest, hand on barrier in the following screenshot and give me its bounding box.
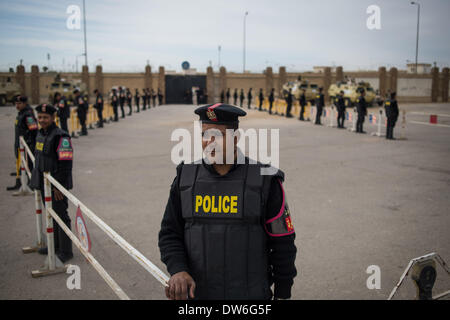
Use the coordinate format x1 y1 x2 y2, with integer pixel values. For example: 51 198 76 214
159 104 297 300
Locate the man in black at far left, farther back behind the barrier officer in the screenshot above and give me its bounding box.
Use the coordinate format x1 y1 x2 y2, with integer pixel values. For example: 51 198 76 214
6 95 38 191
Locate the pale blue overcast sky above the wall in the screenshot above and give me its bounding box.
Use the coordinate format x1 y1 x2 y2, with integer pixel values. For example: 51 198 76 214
0 0 450 72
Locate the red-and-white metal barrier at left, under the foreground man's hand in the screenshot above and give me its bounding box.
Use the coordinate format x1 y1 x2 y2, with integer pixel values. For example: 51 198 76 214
20 137 169 300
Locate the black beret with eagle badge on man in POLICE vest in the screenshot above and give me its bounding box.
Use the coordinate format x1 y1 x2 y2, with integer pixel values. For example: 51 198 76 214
195 103 247 125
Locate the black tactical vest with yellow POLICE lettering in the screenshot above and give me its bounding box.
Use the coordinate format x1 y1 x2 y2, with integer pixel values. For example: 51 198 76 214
179 164 272 300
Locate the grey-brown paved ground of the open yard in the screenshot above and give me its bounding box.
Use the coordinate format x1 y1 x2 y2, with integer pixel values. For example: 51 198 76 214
0 104 450 299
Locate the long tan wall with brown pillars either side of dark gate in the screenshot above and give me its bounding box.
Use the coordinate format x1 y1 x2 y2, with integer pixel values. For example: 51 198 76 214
0 66 450 102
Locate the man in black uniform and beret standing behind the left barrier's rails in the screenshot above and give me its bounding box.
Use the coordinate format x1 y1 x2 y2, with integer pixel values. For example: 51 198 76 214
31 104 73 262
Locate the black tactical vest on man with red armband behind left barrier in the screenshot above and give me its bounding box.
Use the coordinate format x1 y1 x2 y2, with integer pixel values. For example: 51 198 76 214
31 126 72 189
